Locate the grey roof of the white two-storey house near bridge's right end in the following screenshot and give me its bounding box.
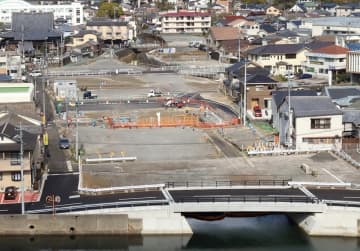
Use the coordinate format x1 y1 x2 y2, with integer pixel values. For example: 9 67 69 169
286 96 342 118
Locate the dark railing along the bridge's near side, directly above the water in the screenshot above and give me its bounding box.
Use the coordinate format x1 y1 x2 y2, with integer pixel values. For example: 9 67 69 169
175 195 320 204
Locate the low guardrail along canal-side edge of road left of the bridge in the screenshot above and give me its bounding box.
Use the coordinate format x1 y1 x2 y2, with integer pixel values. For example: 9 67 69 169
26 200 169 214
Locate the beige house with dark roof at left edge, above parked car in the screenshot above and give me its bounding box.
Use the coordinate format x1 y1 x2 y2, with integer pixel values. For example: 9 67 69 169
0 113 42 191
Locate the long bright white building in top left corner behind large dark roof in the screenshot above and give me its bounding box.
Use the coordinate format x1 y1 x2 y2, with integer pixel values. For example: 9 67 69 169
0 0 84 25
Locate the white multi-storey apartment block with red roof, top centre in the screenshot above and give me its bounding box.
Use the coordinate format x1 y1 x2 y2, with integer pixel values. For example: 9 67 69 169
161 11 211 33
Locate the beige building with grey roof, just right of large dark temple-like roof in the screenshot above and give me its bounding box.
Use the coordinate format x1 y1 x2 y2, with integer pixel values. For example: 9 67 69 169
86 19 136 44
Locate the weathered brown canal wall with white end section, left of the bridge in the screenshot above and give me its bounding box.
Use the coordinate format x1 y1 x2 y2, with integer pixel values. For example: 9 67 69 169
0 210 192 235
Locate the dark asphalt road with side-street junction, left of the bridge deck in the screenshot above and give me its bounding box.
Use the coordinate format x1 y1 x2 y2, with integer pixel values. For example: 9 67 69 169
0 174 166 214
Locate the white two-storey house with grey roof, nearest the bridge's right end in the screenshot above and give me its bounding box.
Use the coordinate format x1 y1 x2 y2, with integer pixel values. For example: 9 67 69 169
279 96 343 151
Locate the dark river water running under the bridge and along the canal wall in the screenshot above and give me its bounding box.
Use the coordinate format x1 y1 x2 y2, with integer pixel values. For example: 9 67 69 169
0 216 360 251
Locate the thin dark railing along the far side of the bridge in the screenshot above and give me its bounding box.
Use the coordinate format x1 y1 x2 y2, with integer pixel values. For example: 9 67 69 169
165 179 291 188
